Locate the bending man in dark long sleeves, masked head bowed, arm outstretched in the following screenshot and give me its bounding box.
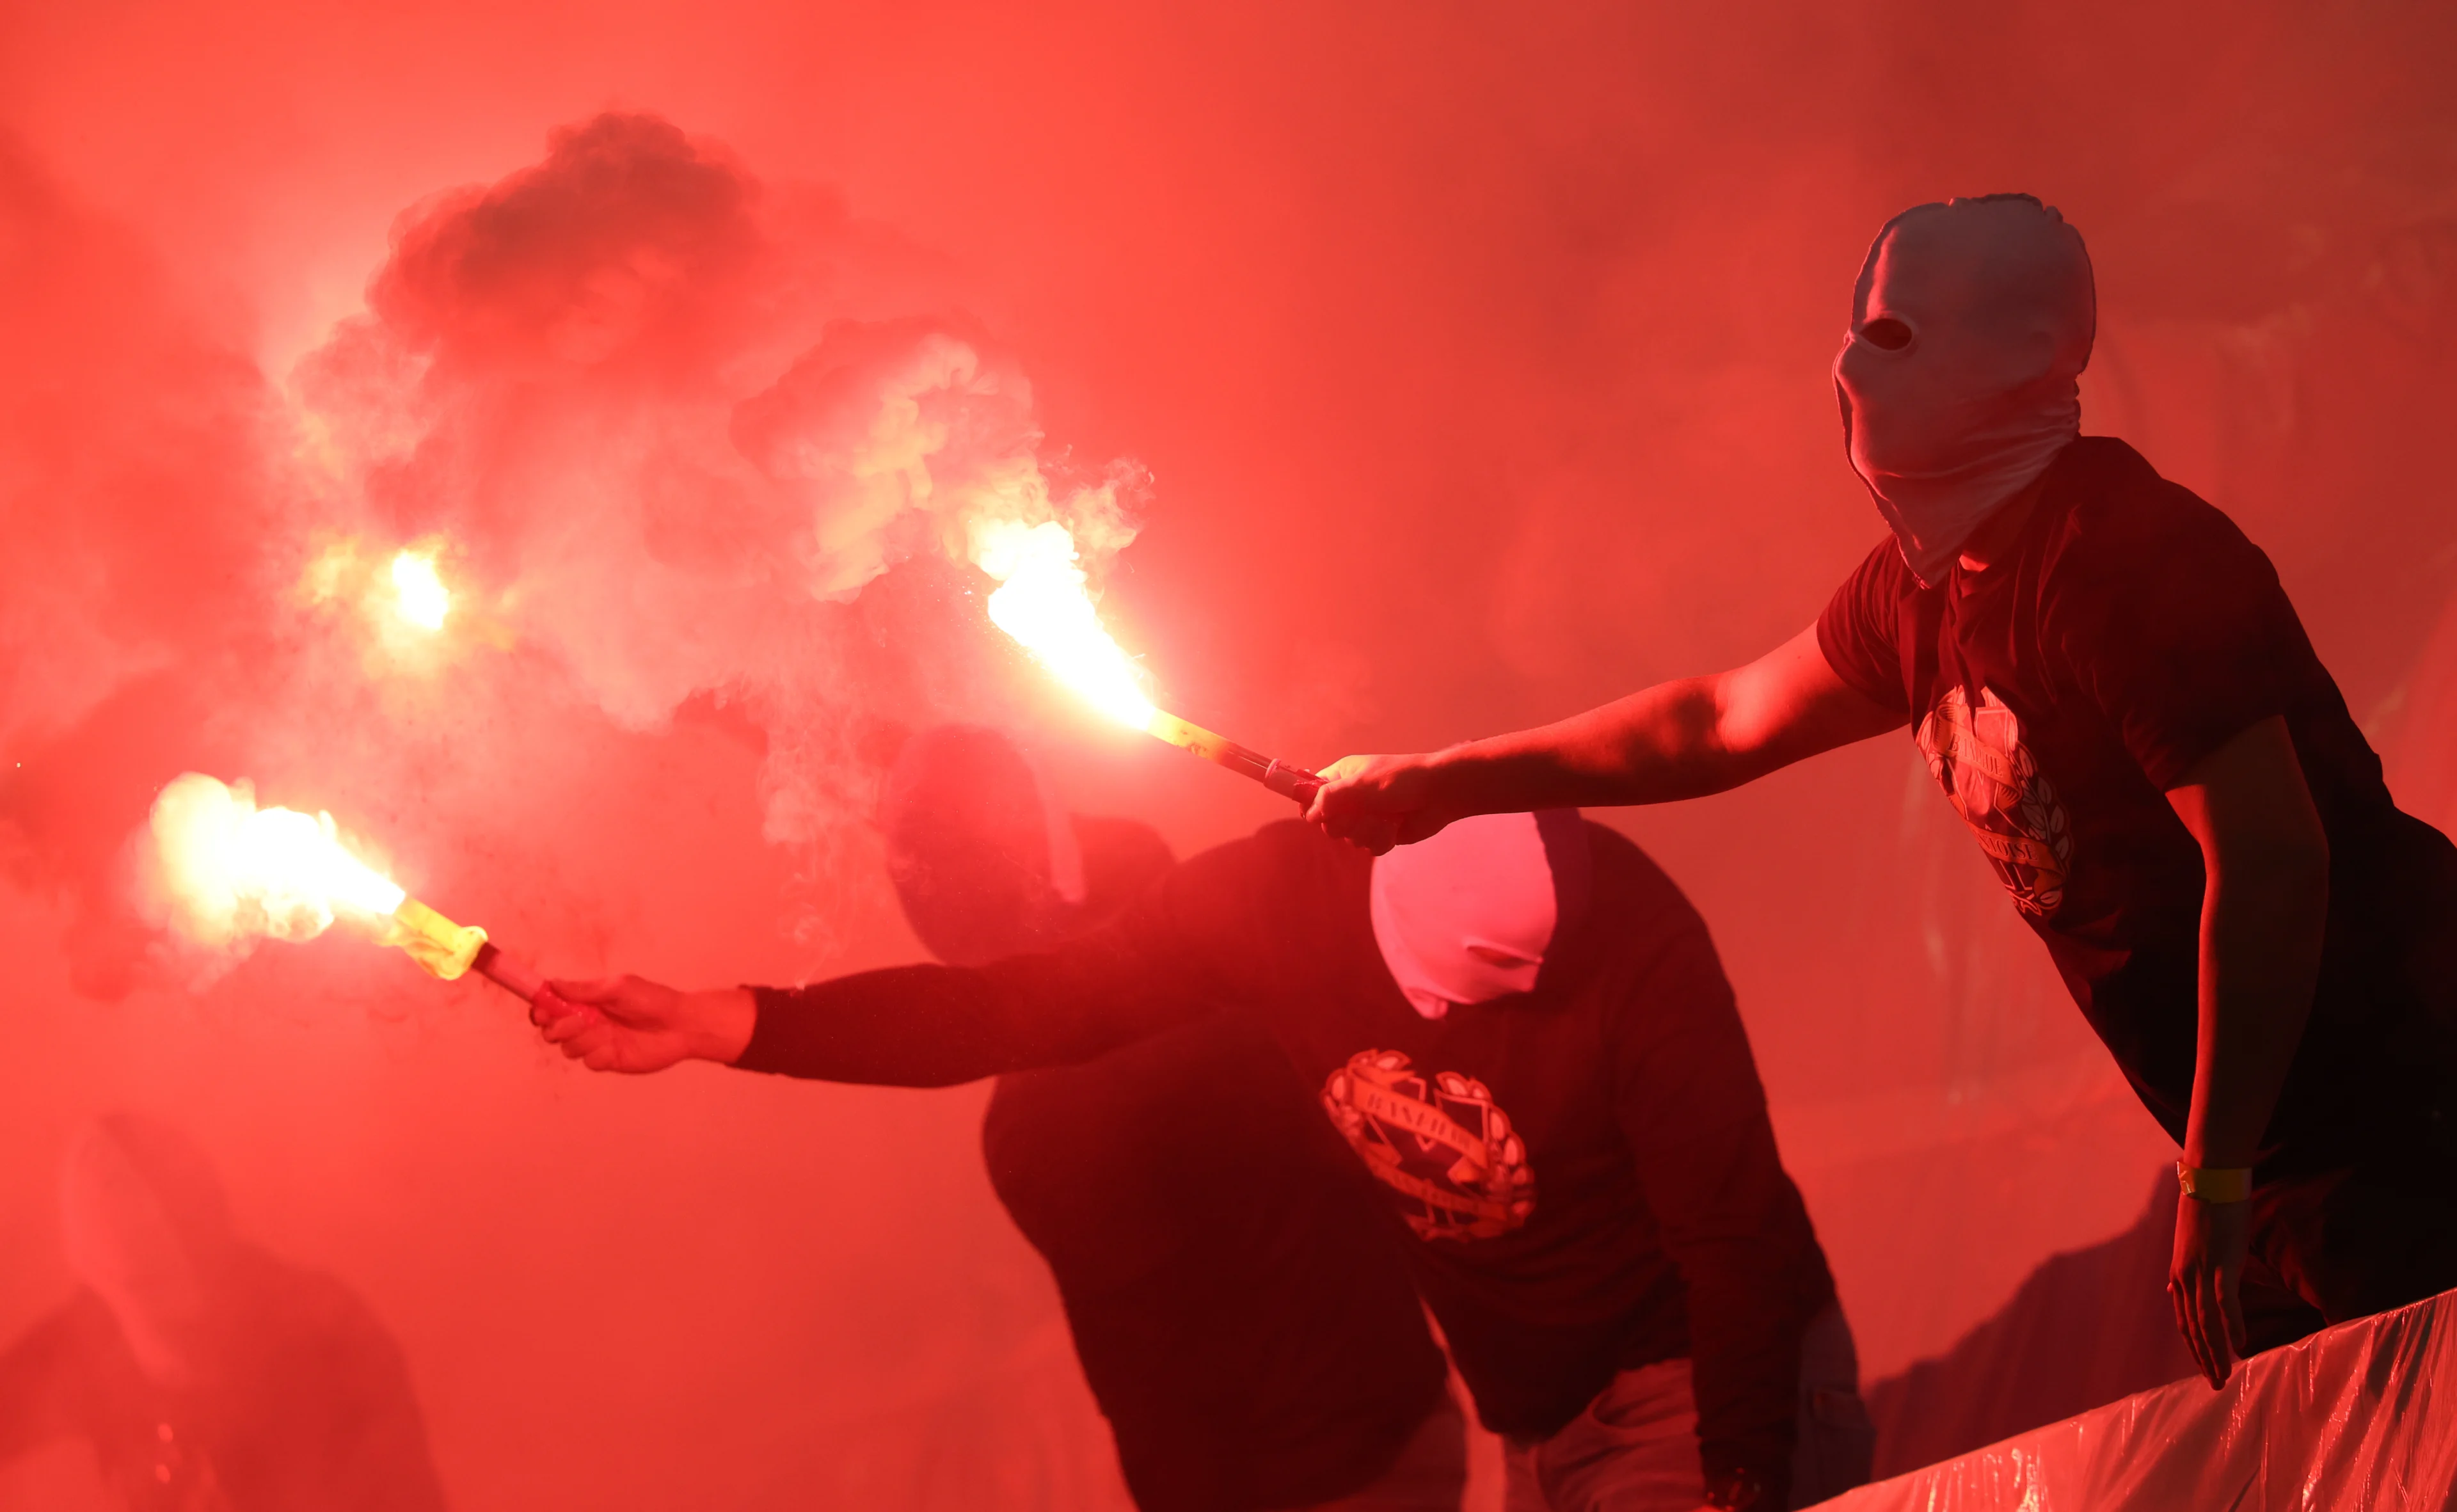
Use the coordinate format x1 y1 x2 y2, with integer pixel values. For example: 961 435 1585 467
541 796 1867 1512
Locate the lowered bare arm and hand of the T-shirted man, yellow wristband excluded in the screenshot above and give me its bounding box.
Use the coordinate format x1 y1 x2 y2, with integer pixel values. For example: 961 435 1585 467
2167 718 2329 1387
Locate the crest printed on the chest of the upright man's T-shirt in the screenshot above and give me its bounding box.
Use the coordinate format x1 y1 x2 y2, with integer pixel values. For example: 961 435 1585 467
1916 688 2074 919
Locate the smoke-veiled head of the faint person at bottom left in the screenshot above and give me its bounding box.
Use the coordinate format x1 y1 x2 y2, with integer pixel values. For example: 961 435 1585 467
59 1114 236 1384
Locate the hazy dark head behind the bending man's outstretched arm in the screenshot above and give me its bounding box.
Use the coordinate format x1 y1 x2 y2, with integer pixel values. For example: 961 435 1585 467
880 725 1083 966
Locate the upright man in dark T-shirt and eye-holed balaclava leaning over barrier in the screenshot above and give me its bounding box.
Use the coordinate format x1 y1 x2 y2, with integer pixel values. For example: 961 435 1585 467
1314 195 2457 1384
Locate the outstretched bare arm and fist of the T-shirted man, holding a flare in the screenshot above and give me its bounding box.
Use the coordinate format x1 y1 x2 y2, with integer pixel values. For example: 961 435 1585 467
1310 627 1902 850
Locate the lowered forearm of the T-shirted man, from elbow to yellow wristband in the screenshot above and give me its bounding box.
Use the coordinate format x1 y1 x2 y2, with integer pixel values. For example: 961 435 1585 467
2184 853 2329 1168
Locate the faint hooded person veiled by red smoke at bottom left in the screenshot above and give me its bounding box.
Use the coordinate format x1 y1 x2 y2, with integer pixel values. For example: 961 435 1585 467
0 1114 445 1512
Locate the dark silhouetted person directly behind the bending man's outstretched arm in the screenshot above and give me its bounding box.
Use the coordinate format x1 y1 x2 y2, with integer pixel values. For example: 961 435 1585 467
880 728 1467 1512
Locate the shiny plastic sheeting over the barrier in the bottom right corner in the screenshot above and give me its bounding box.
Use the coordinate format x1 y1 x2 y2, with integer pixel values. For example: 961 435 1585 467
1823 1291 2457 1512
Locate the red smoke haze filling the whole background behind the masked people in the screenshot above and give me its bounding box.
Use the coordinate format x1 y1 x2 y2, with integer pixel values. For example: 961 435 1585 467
0 0 2457 1509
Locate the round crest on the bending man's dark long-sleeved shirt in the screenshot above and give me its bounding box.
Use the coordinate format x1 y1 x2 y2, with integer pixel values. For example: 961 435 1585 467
1322 1050 1536 1239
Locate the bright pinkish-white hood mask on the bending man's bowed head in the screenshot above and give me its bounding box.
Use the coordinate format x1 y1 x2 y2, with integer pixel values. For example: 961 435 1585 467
1371 809 1589 1018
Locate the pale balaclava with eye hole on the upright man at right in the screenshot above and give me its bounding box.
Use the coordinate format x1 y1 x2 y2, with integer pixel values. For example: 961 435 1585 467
1835 195 2098 587
